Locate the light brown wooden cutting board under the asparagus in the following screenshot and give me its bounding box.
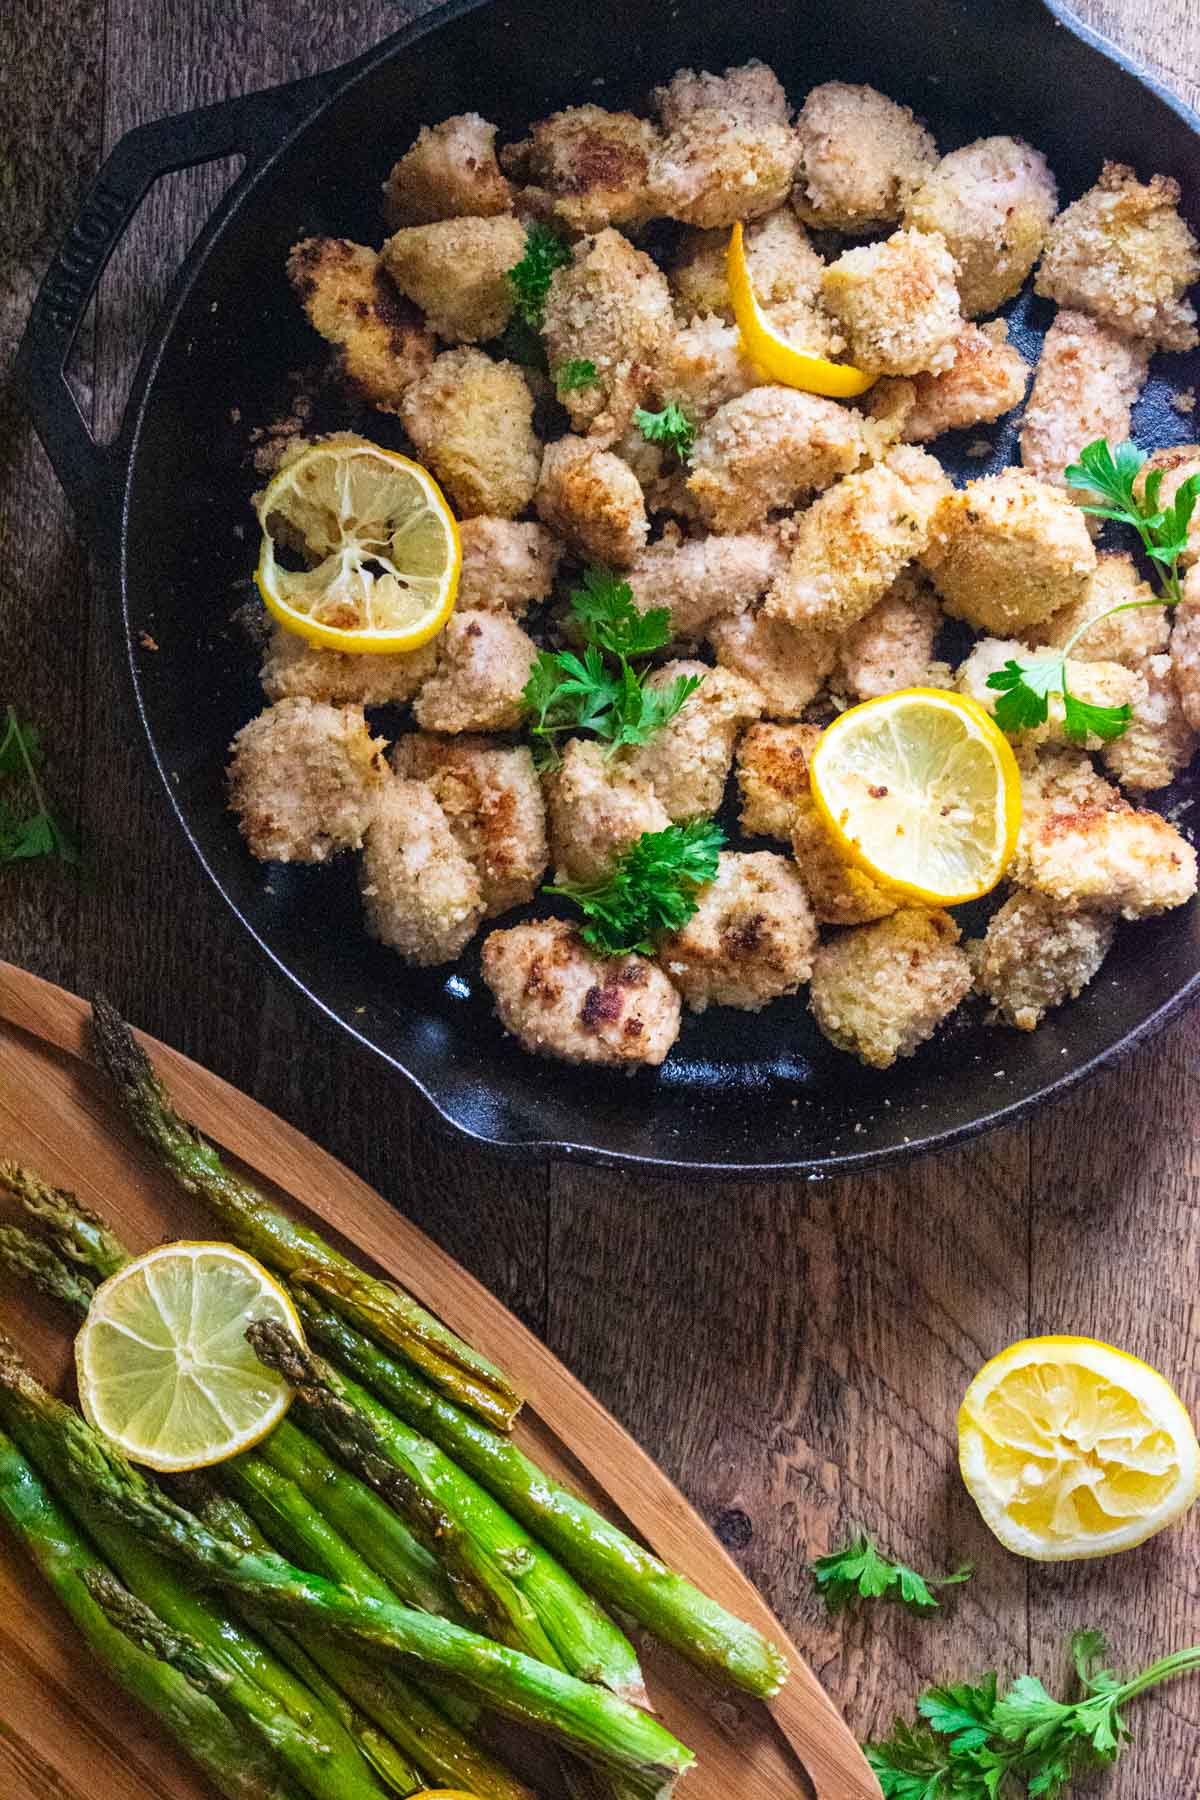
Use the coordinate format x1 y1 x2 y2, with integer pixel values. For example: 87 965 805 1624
0 963 878 1800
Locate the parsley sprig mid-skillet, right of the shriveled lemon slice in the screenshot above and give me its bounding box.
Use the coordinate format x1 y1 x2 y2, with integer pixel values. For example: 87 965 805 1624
524 563 702 769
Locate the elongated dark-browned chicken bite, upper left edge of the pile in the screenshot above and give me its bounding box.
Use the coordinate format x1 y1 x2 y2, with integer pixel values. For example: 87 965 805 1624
288 238 434 412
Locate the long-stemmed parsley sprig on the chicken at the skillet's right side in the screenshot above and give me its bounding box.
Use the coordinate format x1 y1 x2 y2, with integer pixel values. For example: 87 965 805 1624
988 437 1200 743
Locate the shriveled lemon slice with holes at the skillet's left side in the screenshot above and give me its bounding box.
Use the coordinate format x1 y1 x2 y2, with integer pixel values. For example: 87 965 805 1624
255 437 462 653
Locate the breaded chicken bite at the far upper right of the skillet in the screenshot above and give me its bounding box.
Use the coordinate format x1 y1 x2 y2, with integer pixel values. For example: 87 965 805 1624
1034 162 1200 349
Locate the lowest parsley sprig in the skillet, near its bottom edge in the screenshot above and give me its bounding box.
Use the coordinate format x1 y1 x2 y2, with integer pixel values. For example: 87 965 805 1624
543 819 725 956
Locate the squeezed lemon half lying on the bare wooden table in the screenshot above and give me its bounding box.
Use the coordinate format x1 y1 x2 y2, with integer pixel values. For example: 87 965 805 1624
959 1337 1200 1562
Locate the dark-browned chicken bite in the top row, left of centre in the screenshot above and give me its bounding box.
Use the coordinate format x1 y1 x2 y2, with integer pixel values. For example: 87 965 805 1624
500 106 658 232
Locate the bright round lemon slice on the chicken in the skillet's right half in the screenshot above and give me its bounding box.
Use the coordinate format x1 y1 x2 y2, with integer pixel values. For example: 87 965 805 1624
810 688 1020 905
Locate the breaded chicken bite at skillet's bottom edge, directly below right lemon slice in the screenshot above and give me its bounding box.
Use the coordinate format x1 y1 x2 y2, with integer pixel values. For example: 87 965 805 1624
810 907 972 1069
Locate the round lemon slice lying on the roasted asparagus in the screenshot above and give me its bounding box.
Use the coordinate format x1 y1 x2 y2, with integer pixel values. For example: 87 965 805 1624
76 1244 304 1472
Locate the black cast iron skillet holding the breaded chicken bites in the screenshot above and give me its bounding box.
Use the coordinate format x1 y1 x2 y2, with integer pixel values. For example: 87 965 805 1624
20 0 1200 1177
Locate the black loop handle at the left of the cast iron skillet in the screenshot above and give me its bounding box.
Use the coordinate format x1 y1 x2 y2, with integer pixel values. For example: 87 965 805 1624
14 68 345 551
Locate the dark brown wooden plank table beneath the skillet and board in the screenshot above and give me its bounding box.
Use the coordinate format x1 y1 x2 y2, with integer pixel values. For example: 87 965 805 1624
0 0 1200 1800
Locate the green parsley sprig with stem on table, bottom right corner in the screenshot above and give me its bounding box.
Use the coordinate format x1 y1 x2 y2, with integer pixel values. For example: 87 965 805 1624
867 1631 1200 1800
